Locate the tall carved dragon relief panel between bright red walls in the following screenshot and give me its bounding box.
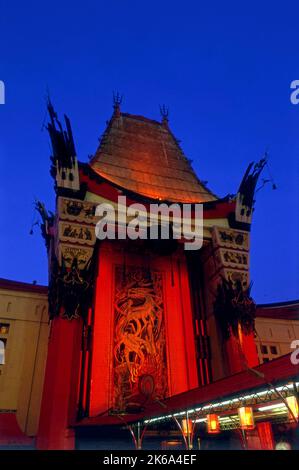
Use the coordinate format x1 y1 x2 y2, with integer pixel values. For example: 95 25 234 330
113 268 167 412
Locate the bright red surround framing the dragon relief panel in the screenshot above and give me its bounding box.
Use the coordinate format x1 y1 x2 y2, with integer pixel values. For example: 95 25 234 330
90 241 198 416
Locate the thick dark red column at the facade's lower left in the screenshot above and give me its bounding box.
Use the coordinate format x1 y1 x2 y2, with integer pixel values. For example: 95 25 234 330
36 317 82 449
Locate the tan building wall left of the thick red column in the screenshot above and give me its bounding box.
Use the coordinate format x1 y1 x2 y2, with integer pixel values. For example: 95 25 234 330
0 281 49 436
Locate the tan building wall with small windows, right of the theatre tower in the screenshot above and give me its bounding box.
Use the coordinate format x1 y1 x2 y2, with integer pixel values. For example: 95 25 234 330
255 316 299 363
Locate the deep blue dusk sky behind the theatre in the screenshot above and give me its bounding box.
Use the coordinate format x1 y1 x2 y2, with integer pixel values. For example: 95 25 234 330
0 0 299 303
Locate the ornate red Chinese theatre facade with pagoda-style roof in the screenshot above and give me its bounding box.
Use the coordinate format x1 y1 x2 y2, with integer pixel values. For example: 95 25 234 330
32 97 298 449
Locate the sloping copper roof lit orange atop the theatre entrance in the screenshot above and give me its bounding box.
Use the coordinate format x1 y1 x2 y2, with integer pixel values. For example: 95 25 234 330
90 112 217 202
